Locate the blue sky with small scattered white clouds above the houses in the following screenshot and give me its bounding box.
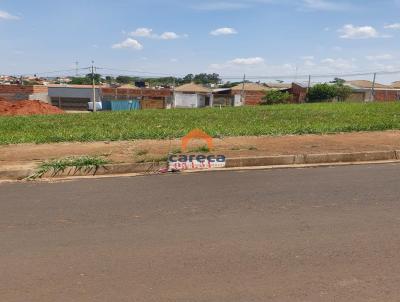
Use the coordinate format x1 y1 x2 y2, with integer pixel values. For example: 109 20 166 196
0 0 400 80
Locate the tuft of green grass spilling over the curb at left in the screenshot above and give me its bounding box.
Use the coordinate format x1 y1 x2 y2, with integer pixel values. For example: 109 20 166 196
28 156 109 180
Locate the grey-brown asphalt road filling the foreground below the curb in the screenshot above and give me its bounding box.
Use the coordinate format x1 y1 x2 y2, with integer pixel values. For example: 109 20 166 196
0 165 400 302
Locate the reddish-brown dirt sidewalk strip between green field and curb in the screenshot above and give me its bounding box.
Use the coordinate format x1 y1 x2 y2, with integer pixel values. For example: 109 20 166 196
0 131 400 167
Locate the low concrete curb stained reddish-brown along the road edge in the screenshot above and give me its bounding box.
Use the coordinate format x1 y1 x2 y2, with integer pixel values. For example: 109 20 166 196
0 150 400 180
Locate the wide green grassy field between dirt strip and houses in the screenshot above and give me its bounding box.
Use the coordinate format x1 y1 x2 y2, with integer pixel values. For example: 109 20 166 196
0 103 400 144
